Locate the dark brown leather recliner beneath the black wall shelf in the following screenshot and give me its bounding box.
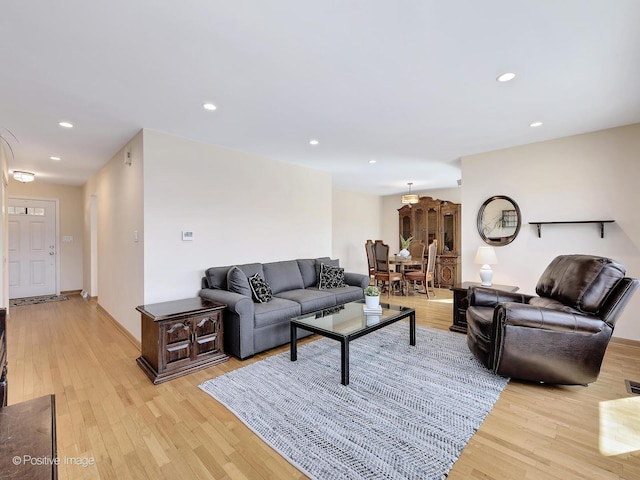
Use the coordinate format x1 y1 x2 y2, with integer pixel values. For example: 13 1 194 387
467 255 640 385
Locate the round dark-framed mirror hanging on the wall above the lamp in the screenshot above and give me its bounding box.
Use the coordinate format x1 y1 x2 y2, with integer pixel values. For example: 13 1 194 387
478 195 522 246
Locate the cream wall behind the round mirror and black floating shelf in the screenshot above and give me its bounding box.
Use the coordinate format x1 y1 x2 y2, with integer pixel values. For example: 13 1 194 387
462 124 640 340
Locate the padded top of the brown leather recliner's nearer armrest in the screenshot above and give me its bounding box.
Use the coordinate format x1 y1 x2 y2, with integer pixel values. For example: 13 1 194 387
494 303 606 334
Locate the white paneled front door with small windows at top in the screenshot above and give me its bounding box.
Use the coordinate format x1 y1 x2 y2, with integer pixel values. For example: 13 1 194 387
7 198 58 298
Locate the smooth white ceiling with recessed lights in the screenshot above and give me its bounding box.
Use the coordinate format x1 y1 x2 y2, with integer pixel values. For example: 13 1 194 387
0 0 640 195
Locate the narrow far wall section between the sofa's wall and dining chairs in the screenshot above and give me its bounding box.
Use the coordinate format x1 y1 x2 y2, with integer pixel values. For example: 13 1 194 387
331 189 382 275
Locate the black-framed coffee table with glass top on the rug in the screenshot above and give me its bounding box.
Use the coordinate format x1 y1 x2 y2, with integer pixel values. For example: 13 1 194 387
291 301 416 385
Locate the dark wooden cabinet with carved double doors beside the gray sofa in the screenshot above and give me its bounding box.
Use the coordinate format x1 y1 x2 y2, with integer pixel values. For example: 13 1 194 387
136 297 229 384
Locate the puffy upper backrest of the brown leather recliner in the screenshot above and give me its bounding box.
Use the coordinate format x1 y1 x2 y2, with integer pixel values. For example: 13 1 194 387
536 255 626 315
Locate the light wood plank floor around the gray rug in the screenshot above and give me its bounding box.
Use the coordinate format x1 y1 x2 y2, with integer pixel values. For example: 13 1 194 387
5 290 640 480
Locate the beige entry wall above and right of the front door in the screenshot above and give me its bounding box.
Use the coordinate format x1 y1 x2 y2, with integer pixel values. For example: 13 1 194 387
8 179 84 292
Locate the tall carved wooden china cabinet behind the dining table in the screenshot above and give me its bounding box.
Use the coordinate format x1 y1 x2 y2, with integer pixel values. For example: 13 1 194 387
398 197 460 287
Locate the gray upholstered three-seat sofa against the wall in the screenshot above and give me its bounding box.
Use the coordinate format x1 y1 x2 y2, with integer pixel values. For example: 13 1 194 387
200 257 369 359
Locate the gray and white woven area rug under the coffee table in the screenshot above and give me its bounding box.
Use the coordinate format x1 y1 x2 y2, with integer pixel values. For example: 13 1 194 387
200 322 508 480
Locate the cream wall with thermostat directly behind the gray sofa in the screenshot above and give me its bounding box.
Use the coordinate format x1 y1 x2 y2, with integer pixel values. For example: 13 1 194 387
142 130 332 303
